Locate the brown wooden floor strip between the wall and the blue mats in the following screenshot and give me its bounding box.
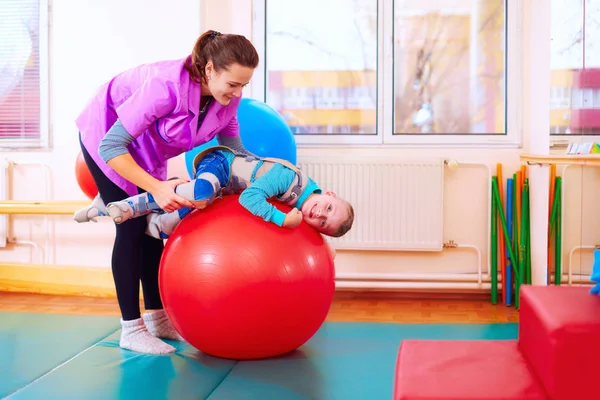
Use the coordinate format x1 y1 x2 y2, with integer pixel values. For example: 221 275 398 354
0 292 519 323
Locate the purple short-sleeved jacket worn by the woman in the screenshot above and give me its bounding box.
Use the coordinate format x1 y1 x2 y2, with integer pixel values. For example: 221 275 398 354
76 56 240 196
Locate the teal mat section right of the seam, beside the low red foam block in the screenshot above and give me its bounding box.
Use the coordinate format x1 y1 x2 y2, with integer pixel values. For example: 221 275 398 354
209 323 518 400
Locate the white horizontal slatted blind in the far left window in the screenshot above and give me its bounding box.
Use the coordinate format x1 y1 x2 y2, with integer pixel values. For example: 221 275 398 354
0 0 40 139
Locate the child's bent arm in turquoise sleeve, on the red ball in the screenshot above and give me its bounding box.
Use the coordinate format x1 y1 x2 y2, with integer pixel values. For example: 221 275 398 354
239 164 296 226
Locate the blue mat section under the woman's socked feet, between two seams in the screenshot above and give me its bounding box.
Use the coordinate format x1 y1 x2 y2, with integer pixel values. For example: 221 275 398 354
10 331 235 400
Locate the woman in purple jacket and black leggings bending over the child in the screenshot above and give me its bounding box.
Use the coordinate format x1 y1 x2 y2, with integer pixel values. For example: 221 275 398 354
76 31 258 354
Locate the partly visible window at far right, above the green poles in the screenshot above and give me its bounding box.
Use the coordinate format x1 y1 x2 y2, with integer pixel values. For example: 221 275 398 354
550 0 600 135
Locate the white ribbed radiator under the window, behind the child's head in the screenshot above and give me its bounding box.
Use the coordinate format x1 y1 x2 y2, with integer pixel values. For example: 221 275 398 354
298 157 444 251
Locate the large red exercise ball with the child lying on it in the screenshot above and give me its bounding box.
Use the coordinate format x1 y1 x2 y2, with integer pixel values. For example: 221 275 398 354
159 195 335 360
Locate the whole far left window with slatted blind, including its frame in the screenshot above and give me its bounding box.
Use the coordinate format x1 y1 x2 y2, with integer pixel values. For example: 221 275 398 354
0 0 49 148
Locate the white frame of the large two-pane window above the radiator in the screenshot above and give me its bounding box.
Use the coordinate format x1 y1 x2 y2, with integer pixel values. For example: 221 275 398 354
250 0 524 148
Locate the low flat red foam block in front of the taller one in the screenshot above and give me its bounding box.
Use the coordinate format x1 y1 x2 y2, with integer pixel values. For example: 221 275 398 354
394 340 547 400
